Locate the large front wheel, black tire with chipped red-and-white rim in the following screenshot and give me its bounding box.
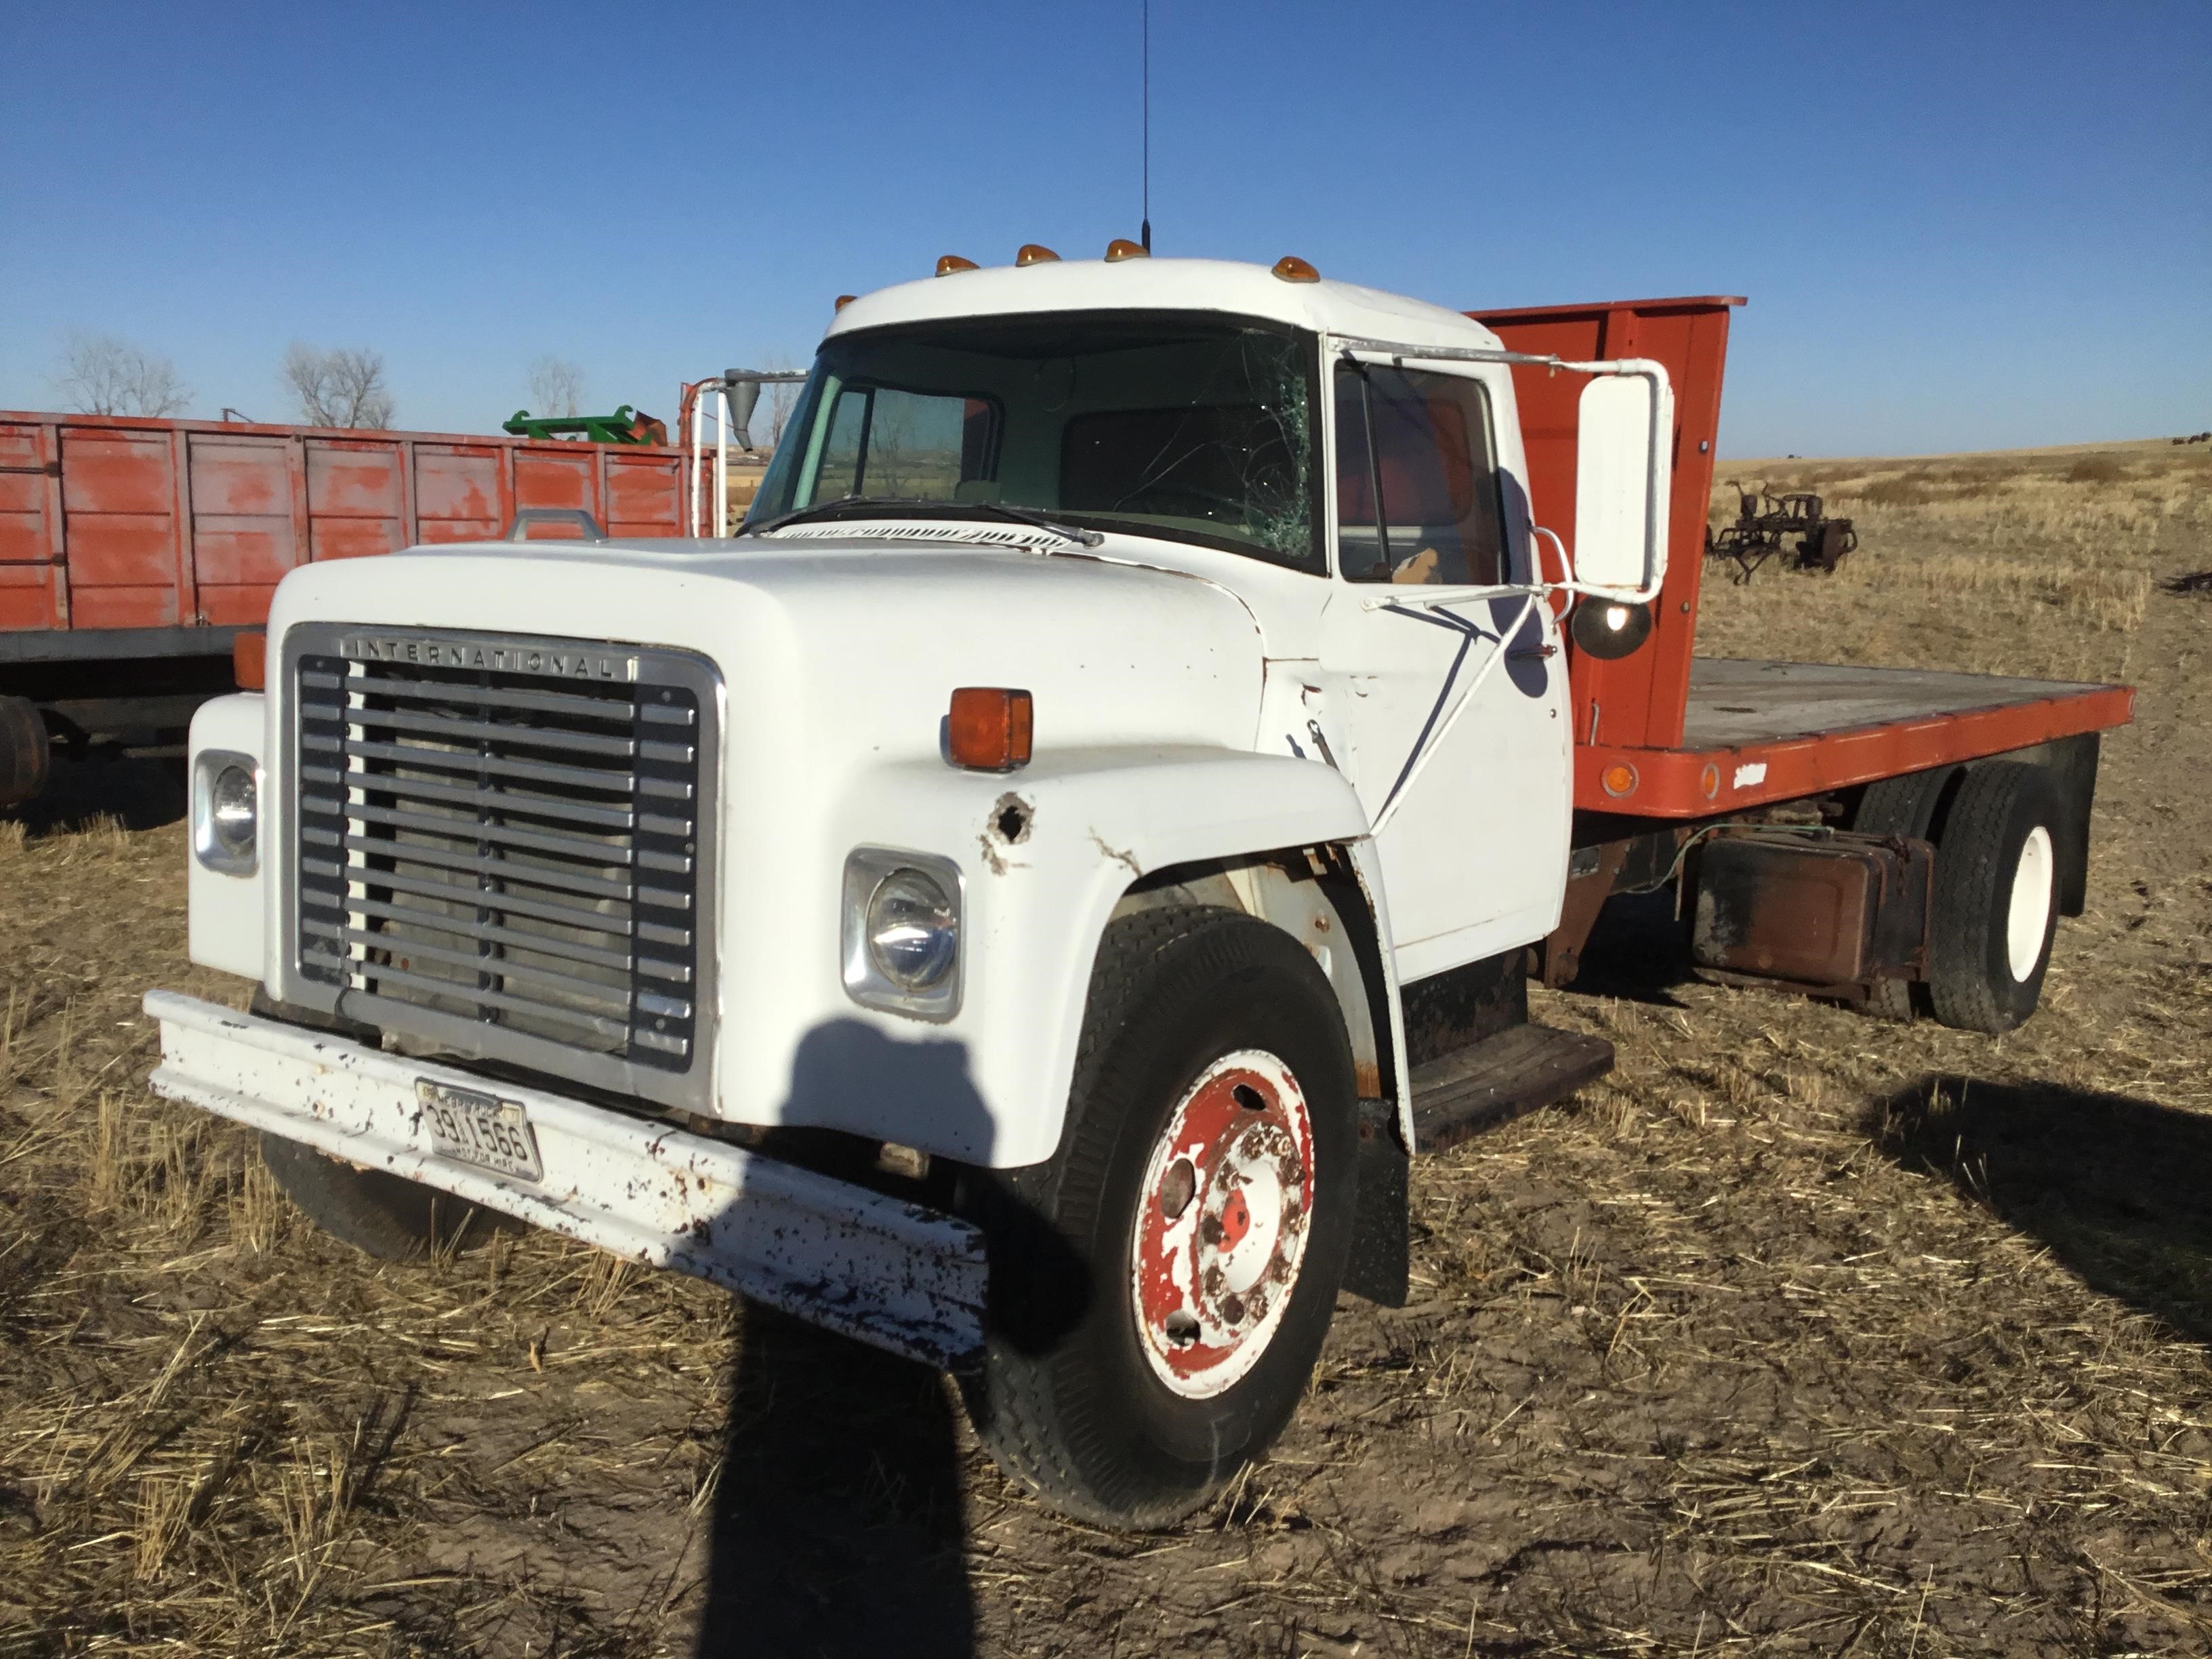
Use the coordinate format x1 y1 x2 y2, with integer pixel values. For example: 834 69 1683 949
962 909 1358 1526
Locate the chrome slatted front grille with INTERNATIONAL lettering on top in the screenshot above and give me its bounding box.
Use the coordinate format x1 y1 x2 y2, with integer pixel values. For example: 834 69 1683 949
285 628 714 1099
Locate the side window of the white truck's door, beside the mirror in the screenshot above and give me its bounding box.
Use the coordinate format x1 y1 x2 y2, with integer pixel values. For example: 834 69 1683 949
1336 363 1507 586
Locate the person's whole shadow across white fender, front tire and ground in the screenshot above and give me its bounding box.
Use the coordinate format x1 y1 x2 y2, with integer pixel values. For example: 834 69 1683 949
697 1020 1086 1659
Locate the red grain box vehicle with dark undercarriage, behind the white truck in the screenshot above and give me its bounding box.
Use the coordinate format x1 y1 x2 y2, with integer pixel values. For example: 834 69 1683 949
0 409 690 807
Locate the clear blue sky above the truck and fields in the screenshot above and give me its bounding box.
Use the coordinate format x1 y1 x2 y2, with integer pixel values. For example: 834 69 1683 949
0 0 2212 455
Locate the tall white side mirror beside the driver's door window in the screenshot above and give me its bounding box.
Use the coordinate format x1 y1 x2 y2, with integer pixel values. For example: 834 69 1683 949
1575 363 1675 602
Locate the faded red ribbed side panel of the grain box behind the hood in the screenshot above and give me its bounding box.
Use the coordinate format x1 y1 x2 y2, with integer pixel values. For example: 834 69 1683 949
0 411 690 650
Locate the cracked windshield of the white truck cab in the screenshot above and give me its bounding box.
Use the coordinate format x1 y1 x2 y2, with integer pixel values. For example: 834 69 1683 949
750 312 1323 571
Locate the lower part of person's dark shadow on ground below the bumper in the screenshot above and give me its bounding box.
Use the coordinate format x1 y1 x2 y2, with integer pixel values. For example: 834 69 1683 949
697 1303 975 1659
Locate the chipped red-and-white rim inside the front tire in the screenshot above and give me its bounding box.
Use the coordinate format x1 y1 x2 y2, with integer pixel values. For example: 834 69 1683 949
1130 1048 1314 1400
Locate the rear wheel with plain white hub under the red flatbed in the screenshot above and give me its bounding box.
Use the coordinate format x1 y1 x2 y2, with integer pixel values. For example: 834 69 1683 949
1929 761 2064 1033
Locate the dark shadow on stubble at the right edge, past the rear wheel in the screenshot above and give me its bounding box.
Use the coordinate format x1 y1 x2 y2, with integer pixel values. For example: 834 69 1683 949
1867 1075 2212 1340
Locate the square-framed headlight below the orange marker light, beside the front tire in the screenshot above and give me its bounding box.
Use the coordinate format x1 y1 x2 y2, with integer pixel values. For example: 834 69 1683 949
843 847 960 1020
